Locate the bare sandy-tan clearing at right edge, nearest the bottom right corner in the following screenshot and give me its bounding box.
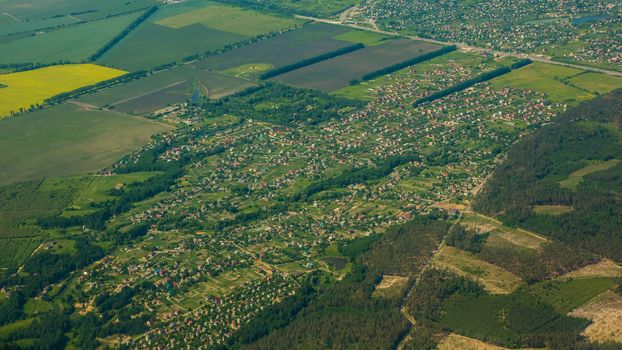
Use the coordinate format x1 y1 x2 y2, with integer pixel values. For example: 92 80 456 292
570 292 622 343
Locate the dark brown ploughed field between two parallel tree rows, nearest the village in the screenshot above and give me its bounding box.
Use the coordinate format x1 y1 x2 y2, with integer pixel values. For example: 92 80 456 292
274 39 439 92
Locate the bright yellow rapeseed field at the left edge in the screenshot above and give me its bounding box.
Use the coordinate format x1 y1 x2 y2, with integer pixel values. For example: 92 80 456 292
0 64 126 119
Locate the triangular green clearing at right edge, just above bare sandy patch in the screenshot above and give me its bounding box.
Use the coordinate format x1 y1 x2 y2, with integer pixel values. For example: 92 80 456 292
529 277 620 315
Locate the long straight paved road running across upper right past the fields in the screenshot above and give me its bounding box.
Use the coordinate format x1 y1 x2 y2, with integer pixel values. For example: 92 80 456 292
296 15 622 77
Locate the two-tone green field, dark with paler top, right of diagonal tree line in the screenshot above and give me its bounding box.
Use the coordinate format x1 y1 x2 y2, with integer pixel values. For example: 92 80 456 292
99 0 300 70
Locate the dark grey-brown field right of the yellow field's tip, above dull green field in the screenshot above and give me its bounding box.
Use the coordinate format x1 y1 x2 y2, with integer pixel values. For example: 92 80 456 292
76 66 253 114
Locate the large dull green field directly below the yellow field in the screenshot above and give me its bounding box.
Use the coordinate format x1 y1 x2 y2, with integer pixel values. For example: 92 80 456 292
0 104 170 184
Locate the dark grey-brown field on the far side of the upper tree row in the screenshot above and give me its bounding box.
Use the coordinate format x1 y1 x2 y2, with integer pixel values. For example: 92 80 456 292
197 23 358 71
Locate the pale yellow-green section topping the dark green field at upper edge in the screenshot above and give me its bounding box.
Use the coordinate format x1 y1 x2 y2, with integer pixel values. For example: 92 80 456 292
156 4 300 37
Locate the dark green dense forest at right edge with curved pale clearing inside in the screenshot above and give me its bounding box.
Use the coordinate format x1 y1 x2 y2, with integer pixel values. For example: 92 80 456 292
475 90 622 261
